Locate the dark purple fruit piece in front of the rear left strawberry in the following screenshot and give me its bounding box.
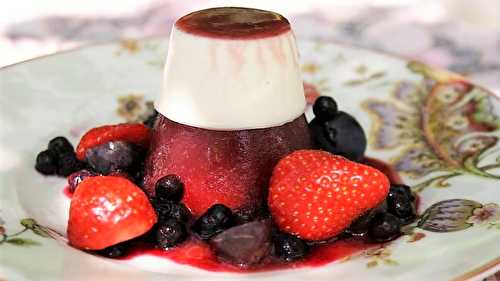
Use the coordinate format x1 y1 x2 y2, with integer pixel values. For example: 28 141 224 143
85 141 137 175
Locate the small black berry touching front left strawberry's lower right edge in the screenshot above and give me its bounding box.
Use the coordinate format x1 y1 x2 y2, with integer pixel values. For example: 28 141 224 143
156 219 187 249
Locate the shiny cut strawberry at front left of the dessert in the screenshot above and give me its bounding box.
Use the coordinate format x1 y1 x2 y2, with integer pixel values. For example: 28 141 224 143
68 176 157 250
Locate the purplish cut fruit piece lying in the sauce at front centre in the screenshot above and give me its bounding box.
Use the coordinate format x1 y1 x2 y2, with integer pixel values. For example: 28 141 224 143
210 219 272 266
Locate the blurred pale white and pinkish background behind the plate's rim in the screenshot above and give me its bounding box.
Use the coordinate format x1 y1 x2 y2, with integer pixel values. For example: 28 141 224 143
0 0 500 94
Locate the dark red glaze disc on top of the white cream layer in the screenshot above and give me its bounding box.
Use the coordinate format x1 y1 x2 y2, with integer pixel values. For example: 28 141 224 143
175 7 290 40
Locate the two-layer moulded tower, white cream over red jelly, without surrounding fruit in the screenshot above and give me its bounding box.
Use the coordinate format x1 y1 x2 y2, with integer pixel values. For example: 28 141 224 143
145 7 312 216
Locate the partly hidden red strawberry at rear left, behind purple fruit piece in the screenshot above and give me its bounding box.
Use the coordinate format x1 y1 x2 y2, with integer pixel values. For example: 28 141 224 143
76 124 150 161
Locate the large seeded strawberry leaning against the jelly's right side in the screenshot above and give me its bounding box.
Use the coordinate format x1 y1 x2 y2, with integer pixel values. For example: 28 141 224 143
268 150 390 240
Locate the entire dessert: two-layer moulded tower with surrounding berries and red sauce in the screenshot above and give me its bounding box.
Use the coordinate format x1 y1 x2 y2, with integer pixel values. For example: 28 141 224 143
35 7 417 272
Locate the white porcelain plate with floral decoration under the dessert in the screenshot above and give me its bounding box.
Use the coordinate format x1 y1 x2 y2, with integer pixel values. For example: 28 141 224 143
0 39 500 281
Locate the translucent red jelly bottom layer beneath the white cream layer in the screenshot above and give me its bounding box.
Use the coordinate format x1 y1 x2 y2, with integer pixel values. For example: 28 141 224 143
144 115 312 217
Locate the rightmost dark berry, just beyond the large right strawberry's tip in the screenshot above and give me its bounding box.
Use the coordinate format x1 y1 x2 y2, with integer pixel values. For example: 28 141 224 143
387 185 417 224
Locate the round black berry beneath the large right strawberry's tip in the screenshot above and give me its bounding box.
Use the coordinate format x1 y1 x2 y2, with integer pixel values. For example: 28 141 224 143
368 213 401 242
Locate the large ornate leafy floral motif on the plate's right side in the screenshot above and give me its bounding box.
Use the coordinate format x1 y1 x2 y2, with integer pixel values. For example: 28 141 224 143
363 62 500 192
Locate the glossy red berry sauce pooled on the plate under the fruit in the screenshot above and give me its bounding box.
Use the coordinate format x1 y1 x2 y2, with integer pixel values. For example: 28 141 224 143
100 155 410 273
